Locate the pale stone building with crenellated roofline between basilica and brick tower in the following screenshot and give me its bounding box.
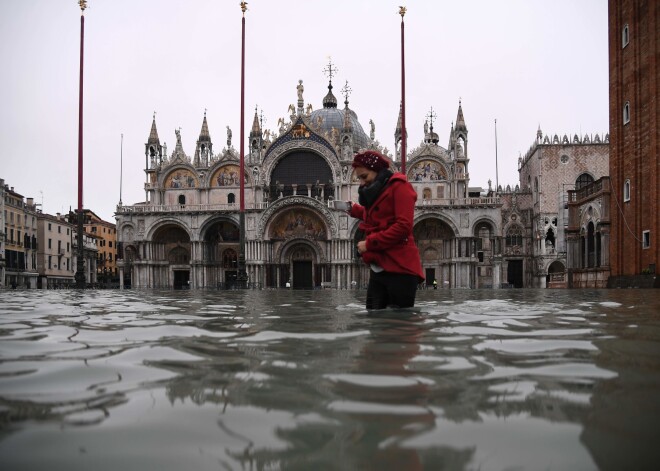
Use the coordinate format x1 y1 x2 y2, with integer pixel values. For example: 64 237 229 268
502 128 609 288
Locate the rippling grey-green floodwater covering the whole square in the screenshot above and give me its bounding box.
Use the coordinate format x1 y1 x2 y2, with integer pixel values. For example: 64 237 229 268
0 290 660 471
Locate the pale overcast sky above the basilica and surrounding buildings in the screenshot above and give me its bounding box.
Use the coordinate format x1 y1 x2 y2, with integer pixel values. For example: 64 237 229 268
0 0 608 221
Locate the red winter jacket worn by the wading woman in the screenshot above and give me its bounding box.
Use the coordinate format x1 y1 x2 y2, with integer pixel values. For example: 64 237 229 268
350 172 424 282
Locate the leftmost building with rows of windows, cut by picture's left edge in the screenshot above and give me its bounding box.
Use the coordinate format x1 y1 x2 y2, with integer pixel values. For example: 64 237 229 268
0 182 38 288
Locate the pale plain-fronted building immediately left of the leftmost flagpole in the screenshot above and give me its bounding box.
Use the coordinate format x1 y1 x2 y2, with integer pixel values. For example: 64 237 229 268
37 213 75 288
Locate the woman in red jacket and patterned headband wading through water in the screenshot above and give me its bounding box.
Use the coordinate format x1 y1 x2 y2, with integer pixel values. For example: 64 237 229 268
349 150 424 309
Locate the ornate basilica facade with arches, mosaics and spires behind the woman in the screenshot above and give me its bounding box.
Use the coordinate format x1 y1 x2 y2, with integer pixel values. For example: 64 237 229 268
116 82 508 289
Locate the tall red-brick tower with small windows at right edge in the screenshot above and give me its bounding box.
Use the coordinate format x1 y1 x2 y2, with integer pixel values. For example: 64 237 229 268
609 0 660 287
